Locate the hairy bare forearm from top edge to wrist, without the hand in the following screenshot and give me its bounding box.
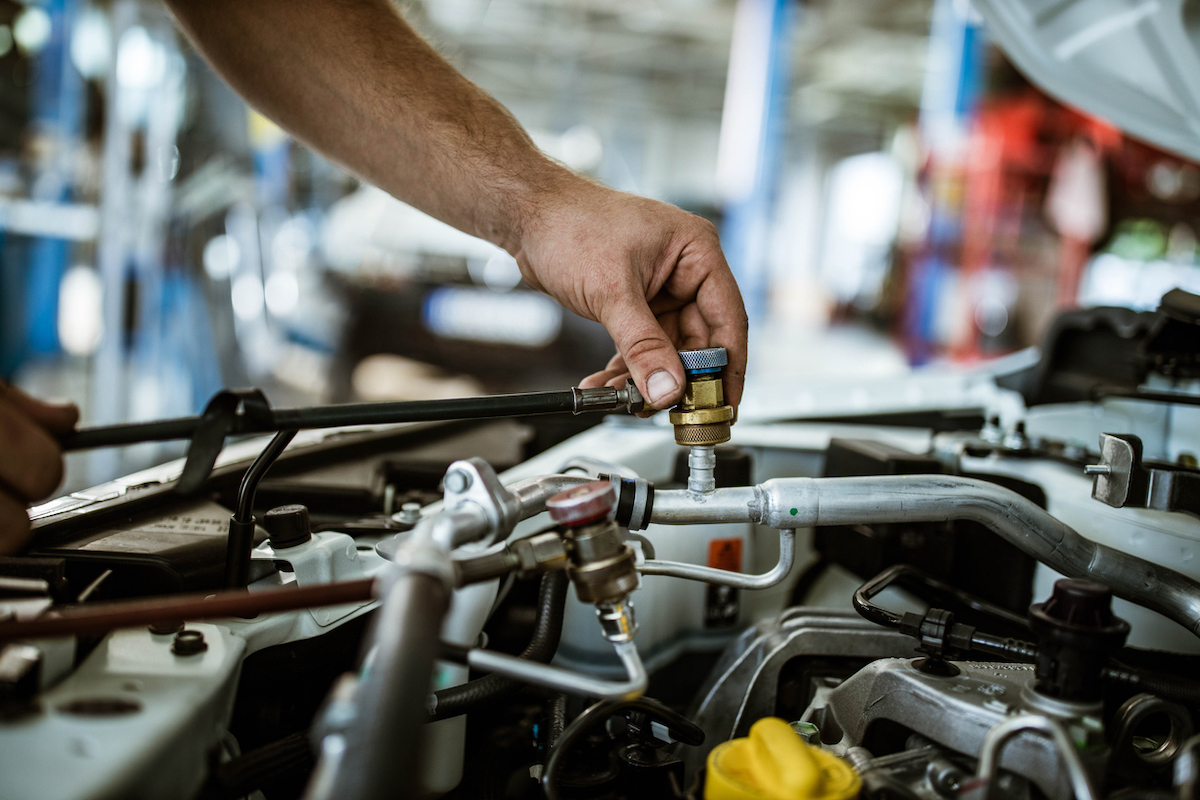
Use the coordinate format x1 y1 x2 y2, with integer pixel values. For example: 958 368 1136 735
168 0 566 252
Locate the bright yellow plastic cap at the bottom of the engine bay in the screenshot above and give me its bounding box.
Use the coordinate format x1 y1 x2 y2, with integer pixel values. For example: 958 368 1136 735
704 717 863 800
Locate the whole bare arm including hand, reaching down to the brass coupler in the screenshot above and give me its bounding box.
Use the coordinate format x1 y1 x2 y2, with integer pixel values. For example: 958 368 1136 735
167 0 746 408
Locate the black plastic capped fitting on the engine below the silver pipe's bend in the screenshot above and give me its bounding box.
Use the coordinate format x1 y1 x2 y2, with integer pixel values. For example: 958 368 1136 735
1030 578 1129 703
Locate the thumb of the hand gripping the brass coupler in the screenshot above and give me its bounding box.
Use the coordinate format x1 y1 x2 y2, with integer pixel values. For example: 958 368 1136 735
600 296 683 409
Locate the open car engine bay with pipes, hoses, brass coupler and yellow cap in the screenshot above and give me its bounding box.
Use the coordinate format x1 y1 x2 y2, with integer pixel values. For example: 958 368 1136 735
0 290 1200 800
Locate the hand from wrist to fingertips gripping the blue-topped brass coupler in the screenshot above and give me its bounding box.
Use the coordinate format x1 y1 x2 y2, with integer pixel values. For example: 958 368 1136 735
515 175 748 409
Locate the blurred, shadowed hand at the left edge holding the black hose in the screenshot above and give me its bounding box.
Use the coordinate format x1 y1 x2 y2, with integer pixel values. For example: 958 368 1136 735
0 381 79 554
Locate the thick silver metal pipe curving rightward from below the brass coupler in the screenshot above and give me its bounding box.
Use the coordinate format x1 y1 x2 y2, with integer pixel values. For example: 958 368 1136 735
650 475 1200 636
